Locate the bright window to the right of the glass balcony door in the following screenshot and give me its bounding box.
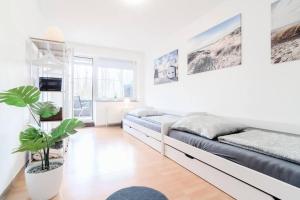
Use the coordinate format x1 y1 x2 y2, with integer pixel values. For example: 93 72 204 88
95 59 136 101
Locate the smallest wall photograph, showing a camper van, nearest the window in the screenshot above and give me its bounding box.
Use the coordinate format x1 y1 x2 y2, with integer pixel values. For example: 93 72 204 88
154 50 178 84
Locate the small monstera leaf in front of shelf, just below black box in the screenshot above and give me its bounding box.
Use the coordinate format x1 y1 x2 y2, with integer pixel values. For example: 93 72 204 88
30 101 59 118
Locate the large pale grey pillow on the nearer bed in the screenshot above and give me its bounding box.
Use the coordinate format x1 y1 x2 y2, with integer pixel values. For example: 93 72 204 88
171 115 247 139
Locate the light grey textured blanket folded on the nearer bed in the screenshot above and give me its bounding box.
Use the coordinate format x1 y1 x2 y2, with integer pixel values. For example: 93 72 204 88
218 130 300 164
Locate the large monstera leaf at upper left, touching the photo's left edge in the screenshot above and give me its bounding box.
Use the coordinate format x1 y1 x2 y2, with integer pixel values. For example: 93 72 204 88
0 85 40 107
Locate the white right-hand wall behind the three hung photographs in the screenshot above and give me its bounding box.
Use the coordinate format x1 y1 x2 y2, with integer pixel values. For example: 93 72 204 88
145 0 300 125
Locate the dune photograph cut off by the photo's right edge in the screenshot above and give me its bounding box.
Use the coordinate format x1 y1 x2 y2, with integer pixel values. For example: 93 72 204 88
271 0 300 64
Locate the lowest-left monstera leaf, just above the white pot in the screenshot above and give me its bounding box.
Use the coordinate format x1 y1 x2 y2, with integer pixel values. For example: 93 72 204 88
13 126 51 153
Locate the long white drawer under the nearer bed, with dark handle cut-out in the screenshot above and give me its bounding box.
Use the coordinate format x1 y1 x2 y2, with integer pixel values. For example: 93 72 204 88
165 145 273 200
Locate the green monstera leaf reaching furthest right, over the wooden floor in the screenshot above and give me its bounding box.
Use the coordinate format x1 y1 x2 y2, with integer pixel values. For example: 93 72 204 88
51 118 84 143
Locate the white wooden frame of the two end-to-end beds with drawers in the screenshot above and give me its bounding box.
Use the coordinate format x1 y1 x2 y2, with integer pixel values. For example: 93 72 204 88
123 119 300 200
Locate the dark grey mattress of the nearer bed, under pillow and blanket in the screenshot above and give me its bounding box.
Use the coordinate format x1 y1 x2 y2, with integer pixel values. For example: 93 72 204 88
169 130 300 188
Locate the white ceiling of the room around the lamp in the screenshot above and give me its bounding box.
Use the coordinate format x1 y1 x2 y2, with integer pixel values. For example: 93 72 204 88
38 0 224 51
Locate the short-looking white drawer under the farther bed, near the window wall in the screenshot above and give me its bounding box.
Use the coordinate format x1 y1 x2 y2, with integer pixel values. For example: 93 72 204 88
123 124 161 152
